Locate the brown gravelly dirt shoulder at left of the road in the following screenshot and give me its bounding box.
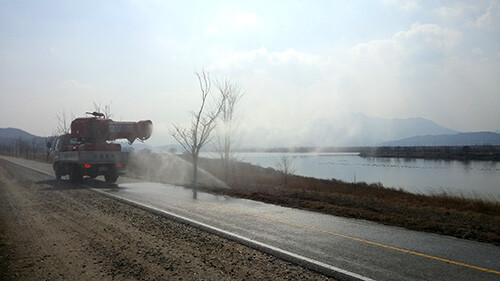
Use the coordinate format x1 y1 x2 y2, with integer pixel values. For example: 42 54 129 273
0 160 328 280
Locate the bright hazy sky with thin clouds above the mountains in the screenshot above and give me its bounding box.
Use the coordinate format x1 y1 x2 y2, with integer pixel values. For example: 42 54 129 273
0 0 500 145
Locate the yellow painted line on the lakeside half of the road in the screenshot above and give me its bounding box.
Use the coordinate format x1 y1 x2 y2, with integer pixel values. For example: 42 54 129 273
200 201 500 275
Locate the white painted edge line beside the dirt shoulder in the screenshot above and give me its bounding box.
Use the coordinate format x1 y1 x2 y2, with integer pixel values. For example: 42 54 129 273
2 158 373 281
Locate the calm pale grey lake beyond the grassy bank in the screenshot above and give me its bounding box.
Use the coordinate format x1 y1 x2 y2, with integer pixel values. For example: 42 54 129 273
216 153 500 201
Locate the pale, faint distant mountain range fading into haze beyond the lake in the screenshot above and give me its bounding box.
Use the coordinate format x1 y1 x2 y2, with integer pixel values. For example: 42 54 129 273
241 113 458 148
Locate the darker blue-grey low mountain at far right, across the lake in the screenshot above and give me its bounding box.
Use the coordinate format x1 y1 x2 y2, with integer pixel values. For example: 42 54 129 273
380 132 500 146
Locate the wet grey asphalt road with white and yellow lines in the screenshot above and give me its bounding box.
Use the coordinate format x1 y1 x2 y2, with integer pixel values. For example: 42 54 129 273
3 155 500 280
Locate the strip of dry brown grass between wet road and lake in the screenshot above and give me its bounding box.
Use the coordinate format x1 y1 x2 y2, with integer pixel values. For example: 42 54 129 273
200 156 500 245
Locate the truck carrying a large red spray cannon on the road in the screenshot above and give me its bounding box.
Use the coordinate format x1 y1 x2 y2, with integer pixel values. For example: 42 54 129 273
51 112 153 183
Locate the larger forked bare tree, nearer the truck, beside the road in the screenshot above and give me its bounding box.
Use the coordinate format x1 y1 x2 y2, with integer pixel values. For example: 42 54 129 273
170 70 225 187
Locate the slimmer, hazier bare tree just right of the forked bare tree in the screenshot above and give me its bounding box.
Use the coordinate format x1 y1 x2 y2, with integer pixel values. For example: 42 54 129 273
215 79 243 183
